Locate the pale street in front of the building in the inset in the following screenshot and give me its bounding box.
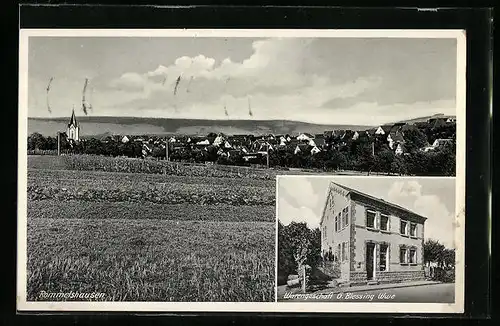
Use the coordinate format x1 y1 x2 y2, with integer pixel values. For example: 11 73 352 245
278 283 455 303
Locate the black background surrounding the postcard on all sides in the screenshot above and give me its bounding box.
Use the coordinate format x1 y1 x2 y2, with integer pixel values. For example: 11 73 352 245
4 1 495 325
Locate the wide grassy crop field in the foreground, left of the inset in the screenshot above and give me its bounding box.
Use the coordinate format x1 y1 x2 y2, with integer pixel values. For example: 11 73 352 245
27 156 275 302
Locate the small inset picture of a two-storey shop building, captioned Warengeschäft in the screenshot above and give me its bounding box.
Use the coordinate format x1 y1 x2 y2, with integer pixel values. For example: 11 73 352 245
277 176 463 303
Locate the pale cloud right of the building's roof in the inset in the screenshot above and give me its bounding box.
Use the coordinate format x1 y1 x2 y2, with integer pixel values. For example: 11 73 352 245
388 181 455 248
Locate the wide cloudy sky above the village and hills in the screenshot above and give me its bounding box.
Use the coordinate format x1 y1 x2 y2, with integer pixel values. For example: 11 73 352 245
28 36 457 125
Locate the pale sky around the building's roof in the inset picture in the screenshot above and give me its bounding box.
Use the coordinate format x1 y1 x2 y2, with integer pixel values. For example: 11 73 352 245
277 177 455 248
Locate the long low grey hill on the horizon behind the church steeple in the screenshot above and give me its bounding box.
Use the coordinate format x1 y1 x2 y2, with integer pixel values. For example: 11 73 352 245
28 117 373 136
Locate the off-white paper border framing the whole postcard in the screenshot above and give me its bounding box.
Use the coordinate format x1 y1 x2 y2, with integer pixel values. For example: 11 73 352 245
16 29 466 313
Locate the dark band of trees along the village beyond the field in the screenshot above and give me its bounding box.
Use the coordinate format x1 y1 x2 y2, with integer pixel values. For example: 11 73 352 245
28 121 456 176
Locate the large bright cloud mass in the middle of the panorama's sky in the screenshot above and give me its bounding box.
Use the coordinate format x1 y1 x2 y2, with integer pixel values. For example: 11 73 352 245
101 39 392 120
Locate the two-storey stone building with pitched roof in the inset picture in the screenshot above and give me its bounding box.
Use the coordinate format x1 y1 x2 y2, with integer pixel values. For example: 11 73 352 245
320 182 426 285
